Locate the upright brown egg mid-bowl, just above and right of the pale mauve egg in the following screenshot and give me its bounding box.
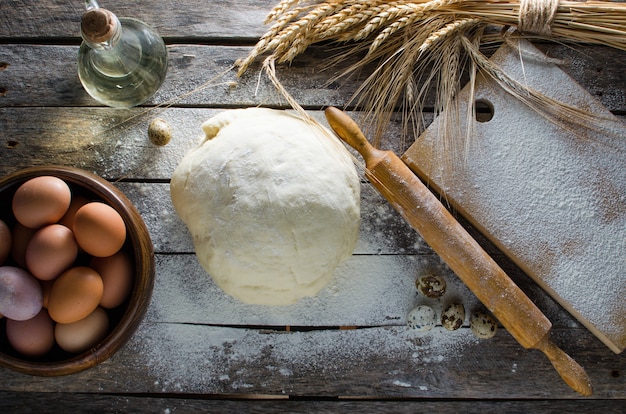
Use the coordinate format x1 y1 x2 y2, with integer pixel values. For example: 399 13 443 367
26 224 78 280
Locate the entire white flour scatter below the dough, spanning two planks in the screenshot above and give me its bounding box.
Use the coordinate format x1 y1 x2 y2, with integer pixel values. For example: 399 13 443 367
128 230 479 394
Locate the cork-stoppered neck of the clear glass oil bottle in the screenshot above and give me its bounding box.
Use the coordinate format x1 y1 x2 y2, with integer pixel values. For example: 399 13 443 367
80 8 122 50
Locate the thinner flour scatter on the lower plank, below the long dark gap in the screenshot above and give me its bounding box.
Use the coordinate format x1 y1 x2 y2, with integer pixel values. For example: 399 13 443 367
129 324 477 393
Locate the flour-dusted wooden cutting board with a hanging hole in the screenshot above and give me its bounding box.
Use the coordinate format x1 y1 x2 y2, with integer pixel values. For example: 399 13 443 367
402 38 626 353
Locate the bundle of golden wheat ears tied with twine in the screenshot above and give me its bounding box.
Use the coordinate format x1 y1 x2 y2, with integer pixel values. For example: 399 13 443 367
238 0 626 157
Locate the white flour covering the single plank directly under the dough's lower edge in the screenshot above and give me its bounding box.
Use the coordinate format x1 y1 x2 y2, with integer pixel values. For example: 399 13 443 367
145 255 479 327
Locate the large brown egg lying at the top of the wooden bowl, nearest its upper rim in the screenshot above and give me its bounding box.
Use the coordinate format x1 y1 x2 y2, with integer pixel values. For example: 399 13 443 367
12 176 72 229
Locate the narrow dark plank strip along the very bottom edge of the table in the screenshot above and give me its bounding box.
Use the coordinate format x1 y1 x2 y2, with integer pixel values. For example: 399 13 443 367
0 392 626 414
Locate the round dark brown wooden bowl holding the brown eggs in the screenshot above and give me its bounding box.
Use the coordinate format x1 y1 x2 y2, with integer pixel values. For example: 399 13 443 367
0 166 154 376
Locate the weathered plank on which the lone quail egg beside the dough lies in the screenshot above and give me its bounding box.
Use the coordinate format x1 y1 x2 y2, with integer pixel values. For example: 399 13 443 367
0 108 410 180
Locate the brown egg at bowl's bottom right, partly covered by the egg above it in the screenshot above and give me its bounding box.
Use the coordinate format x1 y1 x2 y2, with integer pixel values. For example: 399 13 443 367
54 308 109 353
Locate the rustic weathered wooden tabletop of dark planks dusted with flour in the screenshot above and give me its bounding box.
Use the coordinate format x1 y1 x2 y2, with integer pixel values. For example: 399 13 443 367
0 0 626 412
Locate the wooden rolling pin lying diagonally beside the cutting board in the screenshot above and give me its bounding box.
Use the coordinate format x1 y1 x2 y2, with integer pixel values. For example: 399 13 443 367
326 107 592 395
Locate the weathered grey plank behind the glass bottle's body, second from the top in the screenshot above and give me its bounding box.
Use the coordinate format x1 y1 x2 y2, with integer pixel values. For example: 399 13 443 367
0 45 626 113
